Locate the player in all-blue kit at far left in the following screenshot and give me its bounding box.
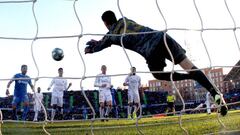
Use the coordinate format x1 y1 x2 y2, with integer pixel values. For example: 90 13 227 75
6 65 34 120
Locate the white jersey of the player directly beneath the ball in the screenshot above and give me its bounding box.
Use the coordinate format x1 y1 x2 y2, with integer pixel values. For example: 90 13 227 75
49 78 67 97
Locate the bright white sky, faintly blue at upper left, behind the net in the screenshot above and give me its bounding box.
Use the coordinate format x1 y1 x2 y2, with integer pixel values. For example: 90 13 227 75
0 0 240 96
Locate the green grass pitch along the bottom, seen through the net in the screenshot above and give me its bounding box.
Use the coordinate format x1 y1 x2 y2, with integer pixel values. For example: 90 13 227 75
1 110 240 135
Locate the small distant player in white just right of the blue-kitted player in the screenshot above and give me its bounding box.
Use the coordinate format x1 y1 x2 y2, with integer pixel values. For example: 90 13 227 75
33 87 43 121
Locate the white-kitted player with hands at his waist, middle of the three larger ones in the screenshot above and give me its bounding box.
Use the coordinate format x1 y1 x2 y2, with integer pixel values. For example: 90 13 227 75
94 65 112 121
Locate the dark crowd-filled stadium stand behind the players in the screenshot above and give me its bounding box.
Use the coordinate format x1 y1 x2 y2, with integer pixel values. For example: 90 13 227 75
0 89 240 120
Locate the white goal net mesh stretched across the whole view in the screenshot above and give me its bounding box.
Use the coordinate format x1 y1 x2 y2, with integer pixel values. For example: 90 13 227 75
0 0 240 134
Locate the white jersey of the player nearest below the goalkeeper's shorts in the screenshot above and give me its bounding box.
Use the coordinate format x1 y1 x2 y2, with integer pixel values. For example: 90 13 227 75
125 75 141 91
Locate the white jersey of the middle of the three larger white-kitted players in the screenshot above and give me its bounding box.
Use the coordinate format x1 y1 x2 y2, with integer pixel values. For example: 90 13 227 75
94 74 111 90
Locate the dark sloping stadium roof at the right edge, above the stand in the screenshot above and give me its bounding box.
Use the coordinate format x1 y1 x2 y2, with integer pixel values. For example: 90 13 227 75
223 60 240 81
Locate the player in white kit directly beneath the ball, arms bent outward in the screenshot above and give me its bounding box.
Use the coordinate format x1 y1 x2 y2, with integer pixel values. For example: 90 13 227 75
48 68 72 121
